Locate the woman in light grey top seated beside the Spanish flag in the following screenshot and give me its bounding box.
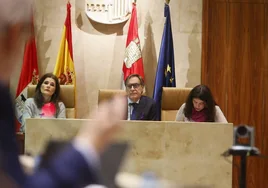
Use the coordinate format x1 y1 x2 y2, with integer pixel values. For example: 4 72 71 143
21 73 66 132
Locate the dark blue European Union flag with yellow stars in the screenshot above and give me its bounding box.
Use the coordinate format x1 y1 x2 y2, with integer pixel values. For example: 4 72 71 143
153 4 176 120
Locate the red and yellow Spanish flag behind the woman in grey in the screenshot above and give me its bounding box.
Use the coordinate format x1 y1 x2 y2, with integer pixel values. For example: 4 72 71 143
53 2 76 86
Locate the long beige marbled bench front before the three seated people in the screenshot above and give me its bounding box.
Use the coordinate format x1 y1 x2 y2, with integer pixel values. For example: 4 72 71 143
25 119 233 188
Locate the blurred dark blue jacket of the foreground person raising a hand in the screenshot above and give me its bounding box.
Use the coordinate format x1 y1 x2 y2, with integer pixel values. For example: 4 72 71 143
0 84 98 188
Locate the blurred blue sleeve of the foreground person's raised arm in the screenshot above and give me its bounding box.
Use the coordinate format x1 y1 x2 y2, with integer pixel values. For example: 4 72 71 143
23 144 100 188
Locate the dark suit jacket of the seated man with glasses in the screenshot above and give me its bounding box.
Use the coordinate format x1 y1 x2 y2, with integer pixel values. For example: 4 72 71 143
130 96 157 121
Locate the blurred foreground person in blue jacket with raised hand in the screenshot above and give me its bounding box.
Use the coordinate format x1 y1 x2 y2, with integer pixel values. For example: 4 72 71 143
0 0 126 188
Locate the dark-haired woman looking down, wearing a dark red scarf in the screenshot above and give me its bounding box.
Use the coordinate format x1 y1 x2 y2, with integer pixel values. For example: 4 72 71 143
176 85 227 123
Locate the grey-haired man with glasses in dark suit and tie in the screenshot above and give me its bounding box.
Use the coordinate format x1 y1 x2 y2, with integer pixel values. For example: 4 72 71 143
125 74 157 121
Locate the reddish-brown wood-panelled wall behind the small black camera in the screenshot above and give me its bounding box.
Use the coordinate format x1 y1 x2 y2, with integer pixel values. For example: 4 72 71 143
202 0 268 188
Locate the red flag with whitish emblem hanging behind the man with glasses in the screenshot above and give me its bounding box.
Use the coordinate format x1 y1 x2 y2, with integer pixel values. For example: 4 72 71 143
123 3 144 80
